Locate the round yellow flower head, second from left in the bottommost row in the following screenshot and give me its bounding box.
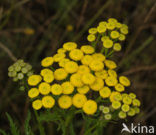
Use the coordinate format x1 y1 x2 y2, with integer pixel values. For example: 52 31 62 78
42 96 55 108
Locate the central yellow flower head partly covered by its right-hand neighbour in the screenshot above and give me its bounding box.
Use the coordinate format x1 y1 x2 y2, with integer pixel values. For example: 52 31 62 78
70 73 83 87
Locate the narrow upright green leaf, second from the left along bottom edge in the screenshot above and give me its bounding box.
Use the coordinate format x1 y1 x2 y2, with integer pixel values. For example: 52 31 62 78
24 111 33 135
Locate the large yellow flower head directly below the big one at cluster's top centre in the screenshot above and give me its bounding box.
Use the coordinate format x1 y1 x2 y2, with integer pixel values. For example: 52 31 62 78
64 61 78 73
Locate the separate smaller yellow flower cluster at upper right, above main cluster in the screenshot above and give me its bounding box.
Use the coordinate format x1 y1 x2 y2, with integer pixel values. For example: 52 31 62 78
87 18 128 51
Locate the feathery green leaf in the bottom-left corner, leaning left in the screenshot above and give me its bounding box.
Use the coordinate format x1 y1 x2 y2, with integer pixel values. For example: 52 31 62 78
6 113 20 135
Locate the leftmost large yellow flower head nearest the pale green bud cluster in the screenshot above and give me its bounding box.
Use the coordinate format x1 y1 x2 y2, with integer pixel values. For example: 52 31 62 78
28 75 42 86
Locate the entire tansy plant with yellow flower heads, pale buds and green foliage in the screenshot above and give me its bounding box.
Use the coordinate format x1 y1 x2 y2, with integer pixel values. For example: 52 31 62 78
9 18 140 135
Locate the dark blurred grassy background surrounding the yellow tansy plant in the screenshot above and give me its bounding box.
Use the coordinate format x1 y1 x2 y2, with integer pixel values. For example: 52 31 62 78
0 0 156 135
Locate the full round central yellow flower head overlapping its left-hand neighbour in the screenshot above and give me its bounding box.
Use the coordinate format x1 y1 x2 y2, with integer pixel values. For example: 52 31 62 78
82 73 95 84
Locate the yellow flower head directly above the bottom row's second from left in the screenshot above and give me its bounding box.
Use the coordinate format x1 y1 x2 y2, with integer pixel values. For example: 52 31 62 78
38 82 50 95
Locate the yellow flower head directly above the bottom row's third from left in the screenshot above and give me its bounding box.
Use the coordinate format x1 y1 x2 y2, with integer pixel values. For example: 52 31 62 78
61 82 74 94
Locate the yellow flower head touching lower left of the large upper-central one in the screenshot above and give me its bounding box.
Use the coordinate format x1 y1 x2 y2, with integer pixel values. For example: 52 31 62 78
54 68 68 80
